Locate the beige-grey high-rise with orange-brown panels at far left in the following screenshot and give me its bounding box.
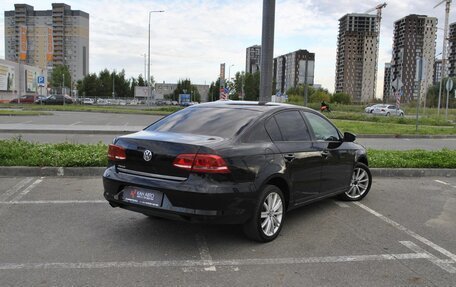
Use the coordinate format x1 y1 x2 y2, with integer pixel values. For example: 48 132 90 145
5 3 89 82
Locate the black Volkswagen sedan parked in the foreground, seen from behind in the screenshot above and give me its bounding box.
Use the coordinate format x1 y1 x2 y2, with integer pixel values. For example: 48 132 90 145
103 101 372 242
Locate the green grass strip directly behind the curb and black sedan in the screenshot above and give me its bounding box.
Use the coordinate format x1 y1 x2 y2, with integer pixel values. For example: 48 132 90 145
0 138 456 168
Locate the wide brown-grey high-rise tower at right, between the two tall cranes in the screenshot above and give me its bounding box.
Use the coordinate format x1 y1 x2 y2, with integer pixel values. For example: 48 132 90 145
391 14 437 102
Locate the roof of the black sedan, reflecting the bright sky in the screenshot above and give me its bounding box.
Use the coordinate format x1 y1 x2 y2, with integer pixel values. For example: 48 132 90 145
188 100 313 112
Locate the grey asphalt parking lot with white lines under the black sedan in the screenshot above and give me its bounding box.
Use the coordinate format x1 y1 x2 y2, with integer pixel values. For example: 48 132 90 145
0 177 456 286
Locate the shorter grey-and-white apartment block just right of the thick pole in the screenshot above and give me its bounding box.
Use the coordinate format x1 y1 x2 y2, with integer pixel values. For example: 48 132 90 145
273 50 315 94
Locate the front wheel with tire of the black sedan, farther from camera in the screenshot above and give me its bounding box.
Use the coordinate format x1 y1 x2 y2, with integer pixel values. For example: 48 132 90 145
339 162 372 201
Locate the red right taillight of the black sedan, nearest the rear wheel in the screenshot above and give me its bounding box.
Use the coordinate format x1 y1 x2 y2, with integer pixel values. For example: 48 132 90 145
173 154 230 173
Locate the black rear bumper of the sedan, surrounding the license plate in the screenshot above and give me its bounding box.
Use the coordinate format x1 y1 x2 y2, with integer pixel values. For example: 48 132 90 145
103 166 257 224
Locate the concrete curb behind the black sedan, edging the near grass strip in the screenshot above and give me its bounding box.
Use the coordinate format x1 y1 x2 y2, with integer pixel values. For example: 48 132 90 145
0 166 456 178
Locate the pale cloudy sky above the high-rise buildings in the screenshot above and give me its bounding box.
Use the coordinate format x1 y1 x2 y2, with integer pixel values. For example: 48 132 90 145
0 0 456 97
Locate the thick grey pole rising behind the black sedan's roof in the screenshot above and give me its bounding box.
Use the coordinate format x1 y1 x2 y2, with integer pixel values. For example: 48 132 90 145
259 0 275 103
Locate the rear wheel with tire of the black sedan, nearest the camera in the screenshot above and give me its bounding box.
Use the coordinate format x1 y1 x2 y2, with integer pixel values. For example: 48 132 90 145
243 185 285 242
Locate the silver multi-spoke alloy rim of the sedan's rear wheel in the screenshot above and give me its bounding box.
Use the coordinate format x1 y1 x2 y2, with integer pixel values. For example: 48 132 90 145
260 192 283 236
